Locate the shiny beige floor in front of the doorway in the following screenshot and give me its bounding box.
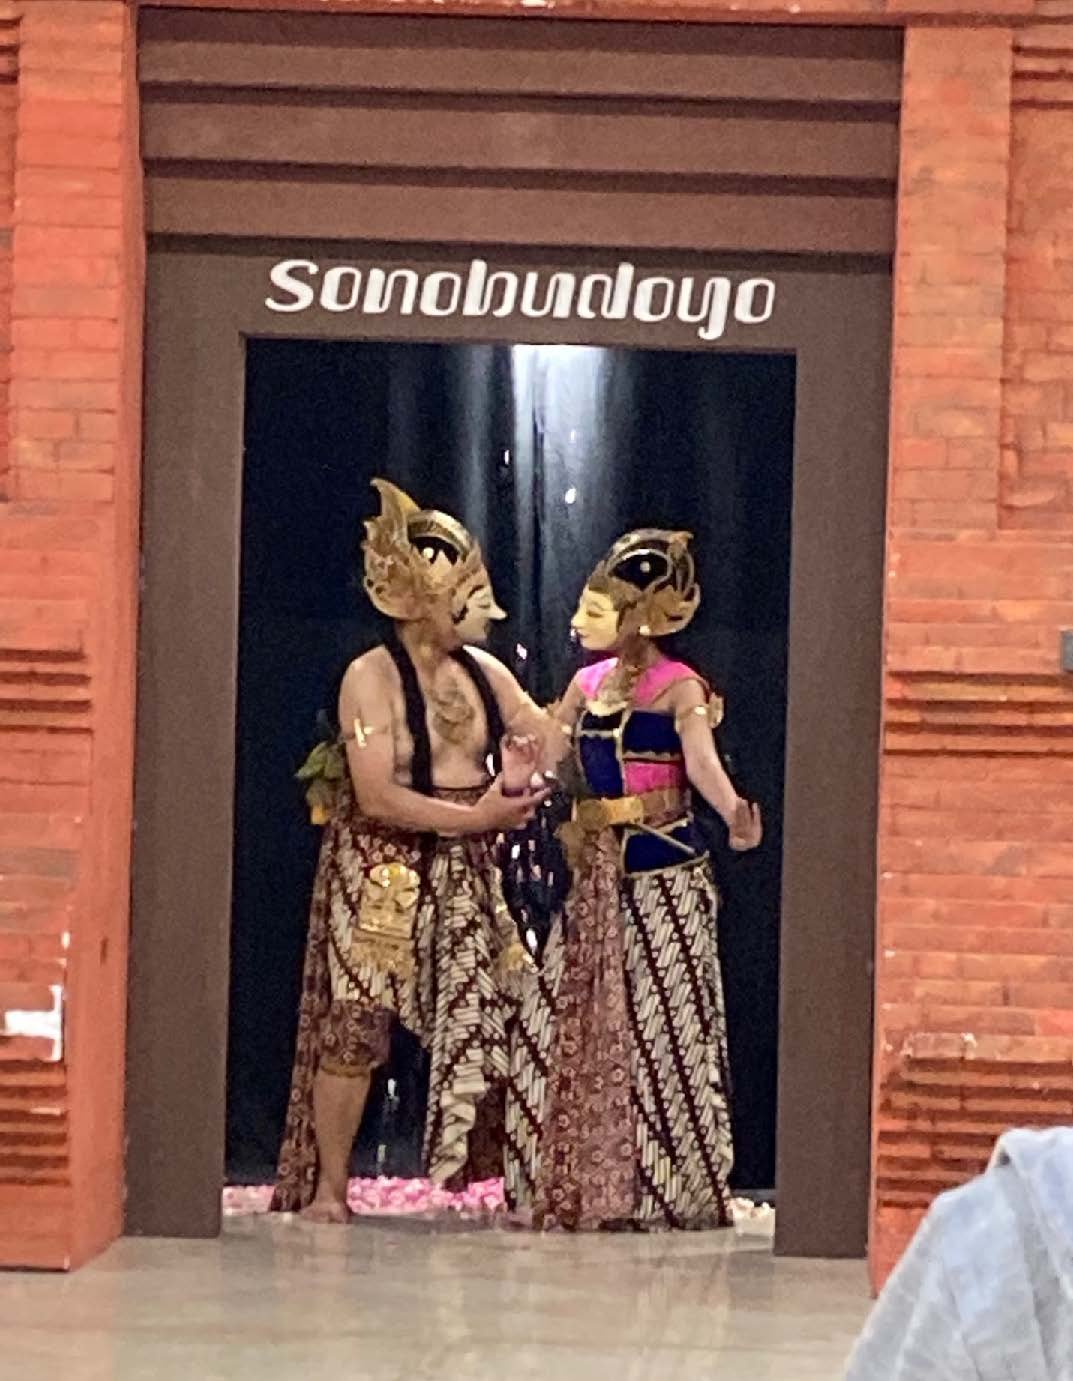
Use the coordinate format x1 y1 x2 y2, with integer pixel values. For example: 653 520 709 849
0 1218 869 1381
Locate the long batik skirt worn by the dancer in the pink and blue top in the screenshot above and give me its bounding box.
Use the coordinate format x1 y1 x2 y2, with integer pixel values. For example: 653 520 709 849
507 831 732 1229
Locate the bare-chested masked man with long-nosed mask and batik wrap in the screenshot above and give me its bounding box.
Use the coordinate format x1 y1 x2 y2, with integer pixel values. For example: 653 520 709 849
273 481 545 1222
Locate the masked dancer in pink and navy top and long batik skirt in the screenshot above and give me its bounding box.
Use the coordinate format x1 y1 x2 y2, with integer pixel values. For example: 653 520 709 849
507 529 761 1229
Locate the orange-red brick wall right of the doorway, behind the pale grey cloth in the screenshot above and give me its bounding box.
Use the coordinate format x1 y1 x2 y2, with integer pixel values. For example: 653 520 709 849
871 21 1073 1283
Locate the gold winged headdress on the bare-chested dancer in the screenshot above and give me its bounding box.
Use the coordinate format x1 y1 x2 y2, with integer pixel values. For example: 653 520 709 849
362 479 494 619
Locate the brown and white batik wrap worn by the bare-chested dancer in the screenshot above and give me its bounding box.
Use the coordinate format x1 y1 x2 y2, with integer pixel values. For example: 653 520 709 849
272 789 528 1211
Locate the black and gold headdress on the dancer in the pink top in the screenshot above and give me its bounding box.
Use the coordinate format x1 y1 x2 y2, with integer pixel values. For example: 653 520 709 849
588 528 700 638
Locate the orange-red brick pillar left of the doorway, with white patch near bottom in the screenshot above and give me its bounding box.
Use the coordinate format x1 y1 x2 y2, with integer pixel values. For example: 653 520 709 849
0 0 144 1266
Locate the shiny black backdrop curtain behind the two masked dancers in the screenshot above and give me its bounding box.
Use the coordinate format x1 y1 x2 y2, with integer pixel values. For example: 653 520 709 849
226 341 794 1188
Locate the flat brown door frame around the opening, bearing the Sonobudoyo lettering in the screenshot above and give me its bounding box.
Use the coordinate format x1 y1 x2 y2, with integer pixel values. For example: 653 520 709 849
127 242 891 1257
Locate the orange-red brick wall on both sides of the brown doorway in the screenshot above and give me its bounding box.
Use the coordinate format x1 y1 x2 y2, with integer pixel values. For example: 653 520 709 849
0 0 1073 1277
